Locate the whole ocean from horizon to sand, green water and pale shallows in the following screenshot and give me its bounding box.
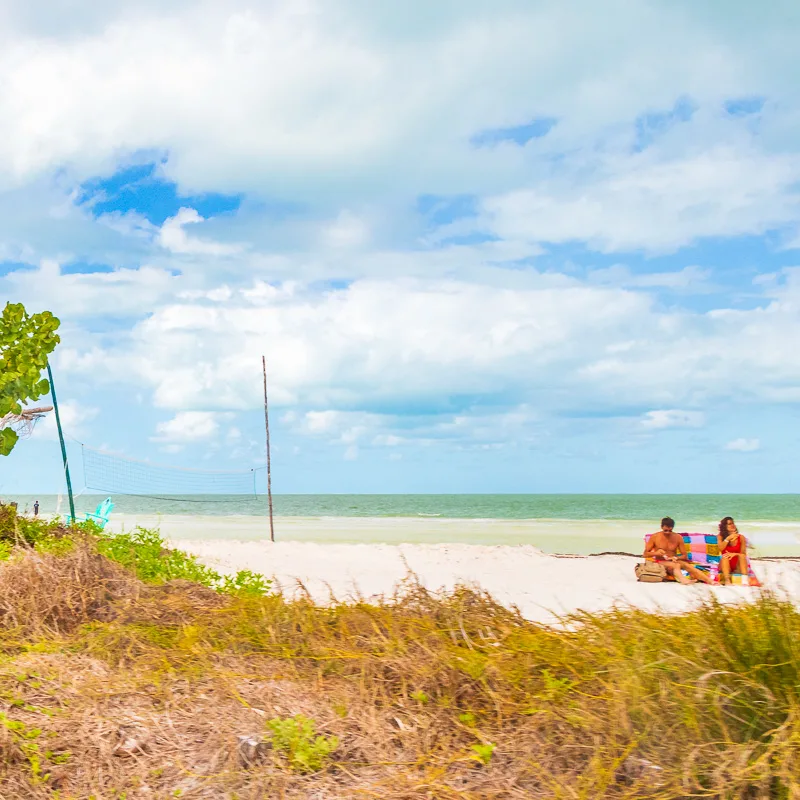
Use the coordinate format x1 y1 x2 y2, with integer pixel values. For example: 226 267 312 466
2 494 800 557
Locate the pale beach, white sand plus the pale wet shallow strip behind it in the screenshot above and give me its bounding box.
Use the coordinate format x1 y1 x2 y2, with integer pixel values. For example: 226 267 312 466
89 514 800 622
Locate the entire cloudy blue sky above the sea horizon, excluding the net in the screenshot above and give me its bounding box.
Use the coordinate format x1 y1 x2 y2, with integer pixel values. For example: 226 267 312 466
0 0 800 494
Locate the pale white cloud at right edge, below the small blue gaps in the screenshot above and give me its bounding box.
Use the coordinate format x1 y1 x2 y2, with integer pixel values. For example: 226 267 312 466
482 147 800 252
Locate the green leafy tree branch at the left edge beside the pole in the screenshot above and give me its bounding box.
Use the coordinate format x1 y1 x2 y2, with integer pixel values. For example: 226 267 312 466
0 303 61 456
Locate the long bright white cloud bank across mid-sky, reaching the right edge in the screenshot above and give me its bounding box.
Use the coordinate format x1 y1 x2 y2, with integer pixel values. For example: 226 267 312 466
47 271 800 434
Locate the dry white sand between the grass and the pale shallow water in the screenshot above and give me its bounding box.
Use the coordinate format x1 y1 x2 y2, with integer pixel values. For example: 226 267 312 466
172 537 800 622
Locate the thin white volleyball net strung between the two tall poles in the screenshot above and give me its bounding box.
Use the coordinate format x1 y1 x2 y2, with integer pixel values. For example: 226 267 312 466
81 445 263 502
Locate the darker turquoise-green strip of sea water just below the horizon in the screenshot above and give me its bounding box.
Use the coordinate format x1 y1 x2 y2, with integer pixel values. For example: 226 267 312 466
3 494 800 528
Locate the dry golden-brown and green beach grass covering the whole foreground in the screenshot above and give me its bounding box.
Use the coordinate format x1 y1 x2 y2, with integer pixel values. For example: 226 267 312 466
0 514 800 800
